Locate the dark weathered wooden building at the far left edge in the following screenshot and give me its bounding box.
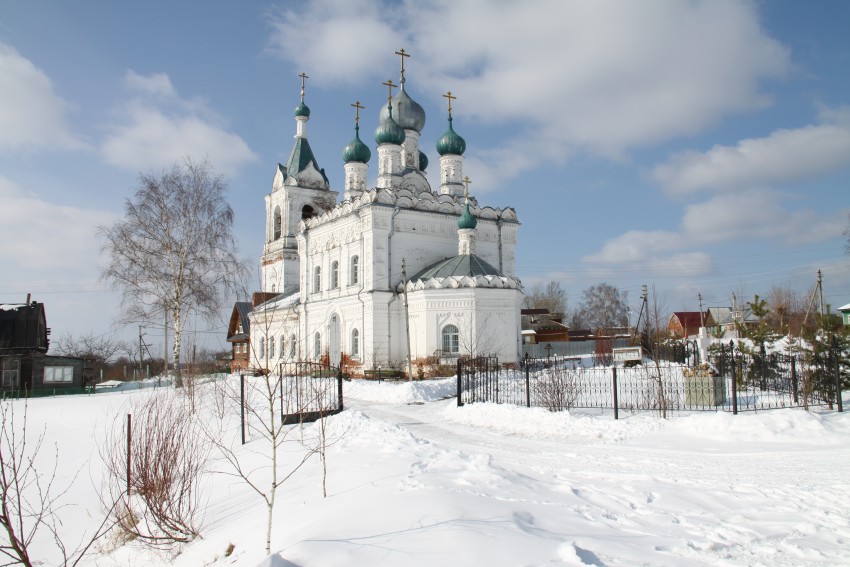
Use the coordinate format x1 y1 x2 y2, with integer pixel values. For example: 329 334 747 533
0 296 94 392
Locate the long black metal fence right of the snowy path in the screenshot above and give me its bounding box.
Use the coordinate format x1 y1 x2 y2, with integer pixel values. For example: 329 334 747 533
457 348 843 418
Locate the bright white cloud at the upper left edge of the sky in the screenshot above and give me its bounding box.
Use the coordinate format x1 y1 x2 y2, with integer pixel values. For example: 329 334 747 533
0 43 86 151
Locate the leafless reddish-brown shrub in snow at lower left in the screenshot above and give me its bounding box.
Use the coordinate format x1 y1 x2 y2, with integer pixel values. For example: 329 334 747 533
104 392 209 546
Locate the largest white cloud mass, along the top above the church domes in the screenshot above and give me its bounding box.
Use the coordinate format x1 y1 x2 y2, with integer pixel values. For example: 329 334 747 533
271 0 790 166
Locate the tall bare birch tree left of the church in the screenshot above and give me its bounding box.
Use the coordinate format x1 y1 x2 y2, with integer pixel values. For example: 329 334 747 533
98 158 247 385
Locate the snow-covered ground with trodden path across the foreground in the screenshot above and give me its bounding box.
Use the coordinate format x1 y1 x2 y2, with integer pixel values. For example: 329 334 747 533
6 378 850 567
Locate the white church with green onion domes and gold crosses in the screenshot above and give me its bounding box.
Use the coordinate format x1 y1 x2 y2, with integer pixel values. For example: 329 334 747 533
235 51 523 372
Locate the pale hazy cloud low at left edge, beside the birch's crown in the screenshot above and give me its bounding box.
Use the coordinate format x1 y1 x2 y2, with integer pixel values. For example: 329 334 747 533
0 176 116 272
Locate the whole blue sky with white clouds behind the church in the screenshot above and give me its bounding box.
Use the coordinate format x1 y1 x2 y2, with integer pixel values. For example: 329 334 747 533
0 0 850 356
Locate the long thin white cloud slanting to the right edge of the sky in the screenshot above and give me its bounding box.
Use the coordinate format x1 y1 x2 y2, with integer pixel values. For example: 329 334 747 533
653 108 850 194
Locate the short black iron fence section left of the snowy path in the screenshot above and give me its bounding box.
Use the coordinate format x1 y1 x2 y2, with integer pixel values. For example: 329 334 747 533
280 362 343 424
